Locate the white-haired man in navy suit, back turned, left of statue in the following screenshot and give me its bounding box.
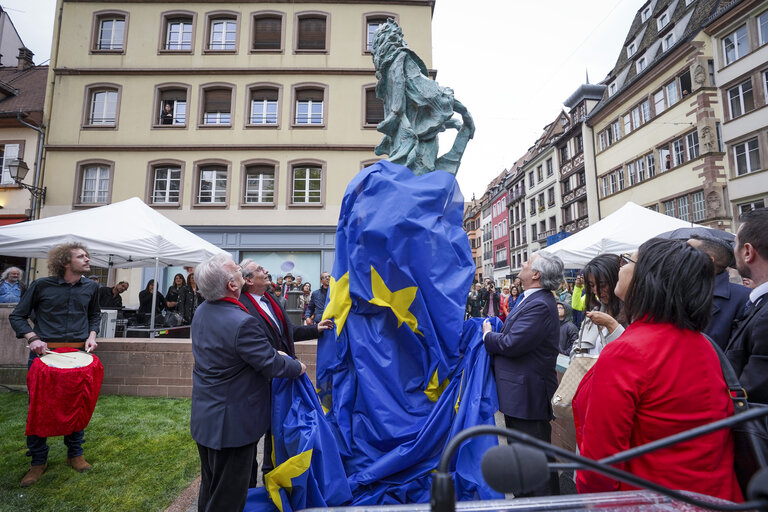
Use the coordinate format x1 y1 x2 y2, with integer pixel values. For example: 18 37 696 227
190 254 306 512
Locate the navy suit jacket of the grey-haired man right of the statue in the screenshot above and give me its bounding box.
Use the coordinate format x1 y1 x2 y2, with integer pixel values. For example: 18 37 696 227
484 290 560 421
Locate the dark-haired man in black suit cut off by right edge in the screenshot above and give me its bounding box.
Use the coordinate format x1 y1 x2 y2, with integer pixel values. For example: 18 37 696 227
725 208 768 404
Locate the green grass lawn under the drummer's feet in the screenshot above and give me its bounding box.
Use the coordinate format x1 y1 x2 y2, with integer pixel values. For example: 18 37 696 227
0 393 200 512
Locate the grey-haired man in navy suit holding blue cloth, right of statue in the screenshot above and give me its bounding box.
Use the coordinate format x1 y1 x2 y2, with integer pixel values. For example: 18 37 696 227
483 252 563 496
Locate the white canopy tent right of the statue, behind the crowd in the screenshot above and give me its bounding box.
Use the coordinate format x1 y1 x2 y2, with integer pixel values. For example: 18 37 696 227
542 202 698 268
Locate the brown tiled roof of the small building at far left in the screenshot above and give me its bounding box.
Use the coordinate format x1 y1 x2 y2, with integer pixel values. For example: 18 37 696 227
0 66 48 118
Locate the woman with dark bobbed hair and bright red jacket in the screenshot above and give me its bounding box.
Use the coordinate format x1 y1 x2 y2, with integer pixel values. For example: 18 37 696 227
573 238 743 501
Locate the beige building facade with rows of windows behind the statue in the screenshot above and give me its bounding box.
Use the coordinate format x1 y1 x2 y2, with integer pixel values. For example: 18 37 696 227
43 0 434 291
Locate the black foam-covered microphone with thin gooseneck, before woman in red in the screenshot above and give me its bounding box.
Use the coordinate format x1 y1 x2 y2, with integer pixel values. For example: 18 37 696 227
482 442 768 512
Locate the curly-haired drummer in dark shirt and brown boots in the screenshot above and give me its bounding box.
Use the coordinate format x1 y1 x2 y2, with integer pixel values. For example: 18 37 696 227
9 243 101 487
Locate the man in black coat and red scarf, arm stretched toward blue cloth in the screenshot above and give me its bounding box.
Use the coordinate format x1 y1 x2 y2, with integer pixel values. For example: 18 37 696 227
240 259 333 487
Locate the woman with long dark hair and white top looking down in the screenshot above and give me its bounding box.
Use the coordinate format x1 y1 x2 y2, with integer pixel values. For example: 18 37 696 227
571 254 626 357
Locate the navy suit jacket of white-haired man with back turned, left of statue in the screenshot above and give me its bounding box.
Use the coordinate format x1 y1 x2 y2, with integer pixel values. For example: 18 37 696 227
190 301 301 450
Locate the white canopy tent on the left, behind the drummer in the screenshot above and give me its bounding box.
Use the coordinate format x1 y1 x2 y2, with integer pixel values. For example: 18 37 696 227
0 197 224 332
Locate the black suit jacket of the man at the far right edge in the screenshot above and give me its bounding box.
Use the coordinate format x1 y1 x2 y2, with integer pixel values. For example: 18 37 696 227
725 293 768 404
